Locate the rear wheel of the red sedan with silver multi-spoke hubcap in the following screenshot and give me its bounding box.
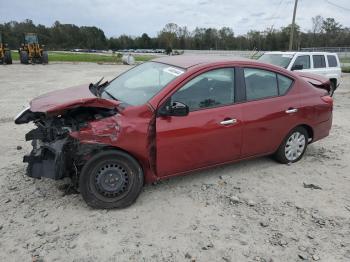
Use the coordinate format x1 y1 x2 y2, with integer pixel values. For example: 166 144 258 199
275 127 309 164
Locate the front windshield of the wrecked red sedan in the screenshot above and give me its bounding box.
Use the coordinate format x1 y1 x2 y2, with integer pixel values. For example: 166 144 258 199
101 62 185 105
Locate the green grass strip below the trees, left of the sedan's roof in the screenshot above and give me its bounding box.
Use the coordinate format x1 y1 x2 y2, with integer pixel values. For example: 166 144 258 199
12 51 155 63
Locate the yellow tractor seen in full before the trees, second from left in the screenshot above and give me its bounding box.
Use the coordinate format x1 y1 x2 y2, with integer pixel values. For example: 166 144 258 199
18 33 49 64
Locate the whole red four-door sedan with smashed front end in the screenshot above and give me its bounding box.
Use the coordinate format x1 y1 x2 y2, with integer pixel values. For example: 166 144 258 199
15 56 333 208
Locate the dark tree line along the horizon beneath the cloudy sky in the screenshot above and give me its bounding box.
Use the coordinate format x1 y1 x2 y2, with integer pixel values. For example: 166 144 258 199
0 16 350 50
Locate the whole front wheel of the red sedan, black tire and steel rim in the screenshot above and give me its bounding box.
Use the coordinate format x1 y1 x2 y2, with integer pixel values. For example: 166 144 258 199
79 150 143 209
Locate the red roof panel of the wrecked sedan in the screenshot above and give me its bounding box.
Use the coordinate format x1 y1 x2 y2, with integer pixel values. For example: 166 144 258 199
152 55 250 69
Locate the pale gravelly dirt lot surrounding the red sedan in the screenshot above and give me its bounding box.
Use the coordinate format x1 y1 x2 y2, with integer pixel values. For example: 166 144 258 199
0 64 350 261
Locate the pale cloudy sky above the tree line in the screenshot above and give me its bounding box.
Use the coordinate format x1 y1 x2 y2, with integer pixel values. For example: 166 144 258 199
0 0 350 37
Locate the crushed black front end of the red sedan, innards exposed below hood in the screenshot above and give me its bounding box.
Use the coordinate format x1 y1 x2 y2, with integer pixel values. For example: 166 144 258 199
15 107 117 180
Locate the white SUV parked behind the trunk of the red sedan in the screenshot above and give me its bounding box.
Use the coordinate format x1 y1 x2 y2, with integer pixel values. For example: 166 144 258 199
258 52 341 95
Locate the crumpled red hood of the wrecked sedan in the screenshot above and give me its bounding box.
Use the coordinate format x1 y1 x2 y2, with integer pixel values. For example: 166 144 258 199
30 85 120 114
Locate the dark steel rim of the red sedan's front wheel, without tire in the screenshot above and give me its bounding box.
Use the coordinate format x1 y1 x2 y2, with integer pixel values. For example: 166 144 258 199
95 164 129 197
